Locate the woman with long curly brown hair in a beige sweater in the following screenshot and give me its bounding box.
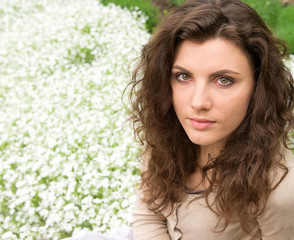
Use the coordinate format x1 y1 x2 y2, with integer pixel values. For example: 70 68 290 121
131 0 294 240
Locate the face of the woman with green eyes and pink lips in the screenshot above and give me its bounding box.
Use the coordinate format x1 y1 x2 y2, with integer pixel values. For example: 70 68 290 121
171 38 254 152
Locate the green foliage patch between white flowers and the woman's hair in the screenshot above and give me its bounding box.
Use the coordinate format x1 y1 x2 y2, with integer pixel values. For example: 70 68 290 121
100 0 160 32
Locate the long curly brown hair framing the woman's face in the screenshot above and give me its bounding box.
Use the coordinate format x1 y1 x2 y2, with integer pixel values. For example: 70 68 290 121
130 0 294 236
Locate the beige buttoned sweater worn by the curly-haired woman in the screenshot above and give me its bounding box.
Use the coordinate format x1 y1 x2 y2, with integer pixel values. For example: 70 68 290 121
132 151 294 240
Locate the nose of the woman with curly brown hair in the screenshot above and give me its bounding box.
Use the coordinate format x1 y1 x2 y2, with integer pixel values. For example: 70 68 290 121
191 82 212 111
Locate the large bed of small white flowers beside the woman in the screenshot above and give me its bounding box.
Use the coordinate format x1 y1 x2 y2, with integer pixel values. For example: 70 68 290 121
0 0 149 240
